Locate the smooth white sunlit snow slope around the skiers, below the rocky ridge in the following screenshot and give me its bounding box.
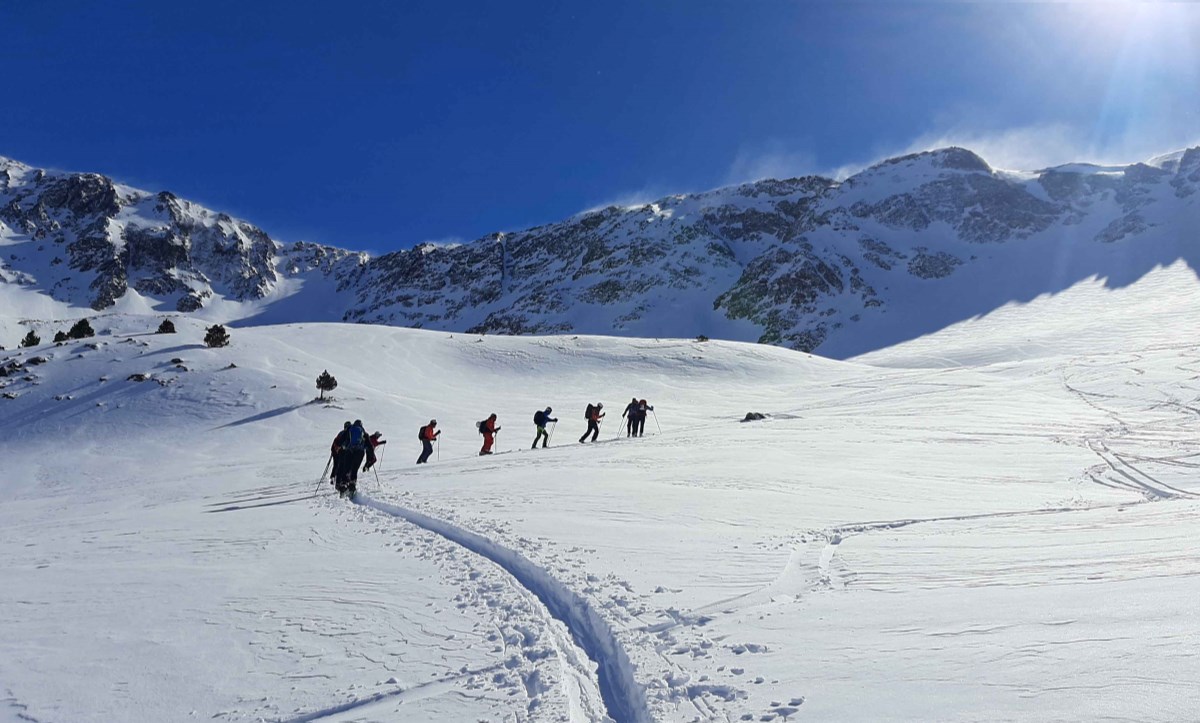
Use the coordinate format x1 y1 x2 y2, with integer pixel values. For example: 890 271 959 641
0 265 1200 723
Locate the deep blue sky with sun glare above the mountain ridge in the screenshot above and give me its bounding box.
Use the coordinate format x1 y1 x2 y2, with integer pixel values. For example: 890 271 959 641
0 0 1200 251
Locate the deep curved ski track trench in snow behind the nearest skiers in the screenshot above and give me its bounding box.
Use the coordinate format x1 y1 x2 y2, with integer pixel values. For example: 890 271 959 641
354 492 653 723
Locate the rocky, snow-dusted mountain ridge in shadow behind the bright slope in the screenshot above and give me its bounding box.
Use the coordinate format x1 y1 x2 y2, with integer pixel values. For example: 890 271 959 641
0 148 1200 357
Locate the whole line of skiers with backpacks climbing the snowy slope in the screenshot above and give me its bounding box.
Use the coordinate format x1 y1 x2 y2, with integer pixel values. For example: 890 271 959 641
329 396 654 485
